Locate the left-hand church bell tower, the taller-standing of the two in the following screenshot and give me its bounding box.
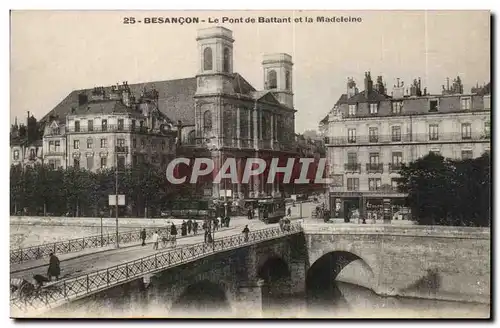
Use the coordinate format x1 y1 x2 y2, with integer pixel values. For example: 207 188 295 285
196 26 234 95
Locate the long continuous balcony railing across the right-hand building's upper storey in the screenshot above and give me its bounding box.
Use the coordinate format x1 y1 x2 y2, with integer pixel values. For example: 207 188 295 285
325 133 490 146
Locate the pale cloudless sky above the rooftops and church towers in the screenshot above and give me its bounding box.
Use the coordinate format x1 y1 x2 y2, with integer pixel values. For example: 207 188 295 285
10 11 490 133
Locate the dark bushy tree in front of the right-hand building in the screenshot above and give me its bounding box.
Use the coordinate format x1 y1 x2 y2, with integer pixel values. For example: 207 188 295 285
400 154 491 226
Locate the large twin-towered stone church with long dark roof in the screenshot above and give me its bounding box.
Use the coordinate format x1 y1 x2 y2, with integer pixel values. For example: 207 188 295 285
41 27 298 199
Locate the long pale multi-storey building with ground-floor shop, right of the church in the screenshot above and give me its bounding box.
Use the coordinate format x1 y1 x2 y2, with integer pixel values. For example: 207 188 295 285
326 73 491 222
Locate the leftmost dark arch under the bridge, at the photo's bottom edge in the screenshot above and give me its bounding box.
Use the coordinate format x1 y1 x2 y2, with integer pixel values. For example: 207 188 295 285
169 280 232 317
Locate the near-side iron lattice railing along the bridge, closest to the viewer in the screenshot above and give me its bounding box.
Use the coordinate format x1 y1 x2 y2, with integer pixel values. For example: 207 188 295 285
10 223 302 316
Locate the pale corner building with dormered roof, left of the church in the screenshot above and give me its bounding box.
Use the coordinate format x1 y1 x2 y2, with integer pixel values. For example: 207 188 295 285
43 82 177 172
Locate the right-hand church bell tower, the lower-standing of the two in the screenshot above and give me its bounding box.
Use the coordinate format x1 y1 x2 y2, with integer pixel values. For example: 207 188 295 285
262 53 293 108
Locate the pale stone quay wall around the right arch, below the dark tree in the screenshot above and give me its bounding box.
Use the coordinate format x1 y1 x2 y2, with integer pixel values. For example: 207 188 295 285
304 225 491 303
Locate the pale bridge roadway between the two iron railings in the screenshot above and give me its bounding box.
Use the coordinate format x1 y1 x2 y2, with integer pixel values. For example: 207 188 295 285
10 217 277 281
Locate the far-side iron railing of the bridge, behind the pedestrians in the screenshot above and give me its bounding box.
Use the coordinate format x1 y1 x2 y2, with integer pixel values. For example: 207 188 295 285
10 225 181 264
